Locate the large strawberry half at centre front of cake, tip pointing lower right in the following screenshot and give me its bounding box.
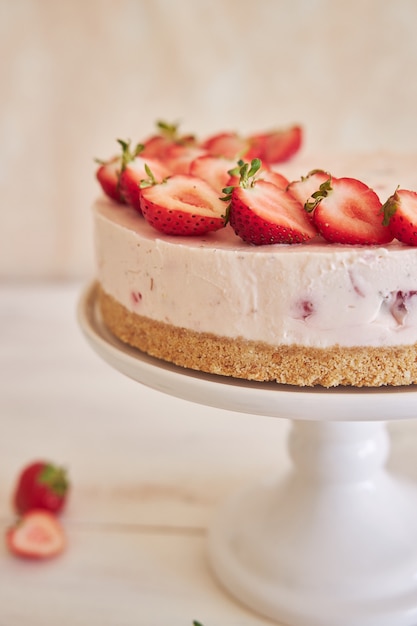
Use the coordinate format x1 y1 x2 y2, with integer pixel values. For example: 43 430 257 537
223 159 317 245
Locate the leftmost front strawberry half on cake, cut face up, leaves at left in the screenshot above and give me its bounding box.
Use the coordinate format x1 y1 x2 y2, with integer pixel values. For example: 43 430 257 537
140 174 226 236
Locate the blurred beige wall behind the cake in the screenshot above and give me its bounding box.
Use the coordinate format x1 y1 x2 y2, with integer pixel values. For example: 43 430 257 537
0 0 417 277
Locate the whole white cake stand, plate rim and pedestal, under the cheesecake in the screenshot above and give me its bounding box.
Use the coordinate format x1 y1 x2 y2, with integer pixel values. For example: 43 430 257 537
78 285 417 626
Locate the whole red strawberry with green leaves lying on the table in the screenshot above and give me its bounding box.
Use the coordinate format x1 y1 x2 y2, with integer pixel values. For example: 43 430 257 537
13 461 69 514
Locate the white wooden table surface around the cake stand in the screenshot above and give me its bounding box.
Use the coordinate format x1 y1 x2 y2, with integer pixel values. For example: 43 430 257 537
0 283 417 626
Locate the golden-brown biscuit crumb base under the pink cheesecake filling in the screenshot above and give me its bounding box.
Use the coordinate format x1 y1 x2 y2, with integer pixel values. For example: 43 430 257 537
98 285 417 387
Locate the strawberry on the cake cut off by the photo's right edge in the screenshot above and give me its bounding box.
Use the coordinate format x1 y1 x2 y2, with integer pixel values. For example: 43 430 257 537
382 189 417 246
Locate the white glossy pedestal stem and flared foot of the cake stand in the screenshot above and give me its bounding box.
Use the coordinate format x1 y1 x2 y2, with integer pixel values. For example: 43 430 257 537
209 421 417 626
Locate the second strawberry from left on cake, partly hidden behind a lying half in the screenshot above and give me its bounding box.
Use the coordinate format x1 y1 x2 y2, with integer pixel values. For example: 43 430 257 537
119 155 171 213
